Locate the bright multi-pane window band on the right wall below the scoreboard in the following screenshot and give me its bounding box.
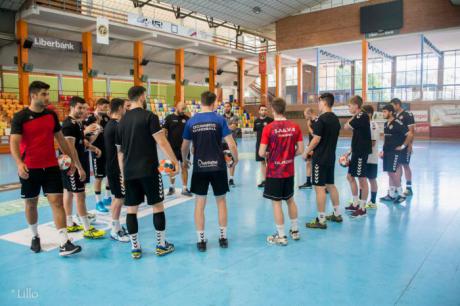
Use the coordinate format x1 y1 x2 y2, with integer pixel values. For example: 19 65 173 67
319 50 460 102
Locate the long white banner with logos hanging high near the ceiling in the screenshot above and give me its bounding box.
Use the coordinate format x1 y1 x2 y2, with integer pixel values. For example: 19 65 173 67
128 13 213 41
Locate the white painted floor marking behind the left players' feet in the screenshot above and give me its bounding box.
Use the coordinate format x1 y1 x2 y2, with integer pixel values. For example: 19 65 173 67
0 192 193 252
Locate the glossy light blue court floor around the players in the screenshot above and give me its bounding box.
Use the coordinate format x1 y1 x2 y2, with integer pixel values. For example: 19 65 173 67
0 139 460 306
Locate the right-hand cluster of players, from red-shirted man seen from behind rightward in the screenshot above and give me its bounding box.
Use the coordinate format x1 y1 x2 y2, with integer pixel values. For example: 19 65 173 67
254 93 415 245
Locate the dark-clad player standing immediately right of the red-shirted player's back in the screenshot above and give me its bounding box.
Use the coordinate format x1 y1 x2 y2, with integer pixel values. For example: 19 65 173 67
303 93 343 229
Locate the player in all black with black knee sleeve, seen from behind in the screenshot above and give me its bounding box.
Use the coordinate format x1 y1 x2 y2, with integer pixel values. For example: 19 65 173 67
117 86 179 259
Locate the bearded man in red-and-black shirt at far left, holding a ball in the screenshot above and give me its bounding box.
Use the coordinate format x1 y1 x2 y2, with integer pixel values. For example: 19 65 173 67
10 81 81 256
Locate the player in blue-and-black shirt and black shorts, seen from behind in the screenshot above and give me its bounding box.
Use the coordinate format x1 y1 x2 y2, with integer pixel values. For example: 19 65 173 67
182 91 238 252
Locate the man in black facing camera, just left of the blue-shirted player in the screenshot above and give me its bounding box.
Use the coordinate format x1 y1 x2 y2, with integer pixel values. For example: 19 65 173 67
163 101 192 196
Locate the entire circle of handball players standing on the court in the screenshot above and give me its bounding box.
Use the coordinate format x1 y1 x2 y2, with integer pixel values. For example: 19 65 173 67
11 81 413 259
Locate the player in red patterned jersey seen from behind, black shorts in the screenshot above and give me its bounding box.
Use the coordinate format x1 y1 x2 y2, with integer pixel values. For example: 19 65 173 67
259 98 303 245
